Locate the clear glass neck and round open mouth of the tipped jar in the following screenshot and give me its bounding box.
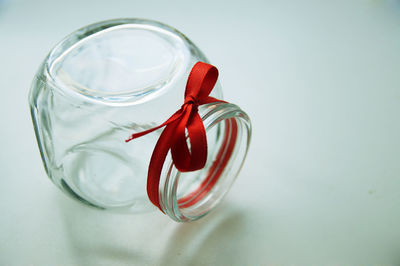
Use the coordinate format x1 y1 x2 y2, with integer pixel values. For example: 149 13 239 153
159 103 251 222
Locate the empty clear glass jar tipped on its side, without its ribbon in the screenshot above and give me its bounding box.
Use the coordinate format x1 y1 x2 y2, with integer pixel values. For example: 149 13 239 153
29 19 251 221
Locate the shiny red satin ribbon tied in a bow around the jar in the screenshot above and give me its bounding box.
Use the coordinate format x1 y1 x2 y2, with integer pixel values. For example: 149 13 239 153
126 62 224 211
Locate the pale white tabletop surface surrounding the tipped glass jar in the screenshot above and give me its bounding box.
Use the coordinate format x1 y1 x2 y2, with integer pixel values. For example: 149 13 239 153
0 0 400 266
